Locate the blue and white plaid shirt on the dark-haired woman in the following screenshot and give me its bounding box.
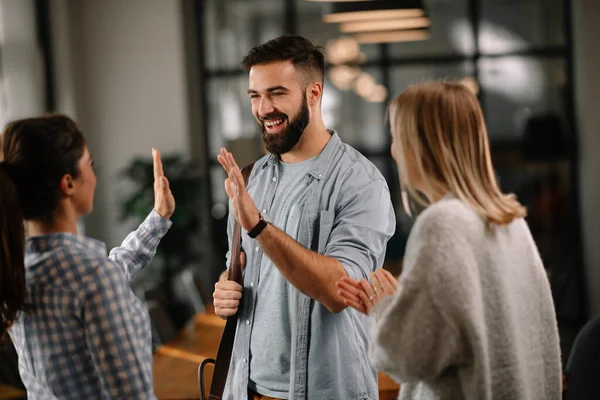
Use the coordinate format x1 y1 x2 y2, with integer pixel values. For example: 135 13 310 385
9 210 171 400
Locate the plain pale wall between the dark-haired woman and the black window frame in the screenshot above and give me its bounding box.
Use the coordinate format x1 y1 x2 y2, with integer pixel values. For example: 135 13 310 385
51 0 190 246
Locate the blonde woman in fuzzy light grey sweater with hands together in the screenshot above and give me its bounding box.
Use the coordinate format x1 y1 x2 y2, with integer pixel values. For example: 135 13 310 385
338 82 561 400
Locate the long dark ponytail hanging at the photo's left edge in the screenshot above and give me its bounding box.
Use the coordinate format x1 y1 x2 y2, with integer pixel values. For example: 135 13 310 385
0 161 27 338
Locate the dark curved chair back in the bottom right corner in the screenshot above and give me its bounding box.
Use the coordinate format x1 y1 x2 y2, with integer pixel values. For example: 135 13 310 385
563 316 600 400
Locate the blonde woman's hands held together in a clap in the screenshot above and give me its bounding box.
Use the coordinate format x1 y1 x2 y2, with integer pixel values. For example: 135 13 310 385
336 268 398 315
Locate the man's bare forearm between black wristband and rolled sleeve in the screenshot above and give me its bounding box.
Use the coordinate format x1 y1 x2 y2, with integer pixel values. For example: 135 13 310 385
257 225 347 313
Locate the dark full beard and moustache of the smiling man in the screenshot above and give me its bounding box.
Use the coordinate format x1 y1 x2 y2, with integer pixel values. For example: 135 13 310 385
258 96 310 156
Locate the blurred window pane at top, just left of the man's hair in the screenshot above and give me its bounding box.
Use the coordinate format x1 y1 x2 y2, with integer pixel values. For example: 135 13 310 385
203 0 285 70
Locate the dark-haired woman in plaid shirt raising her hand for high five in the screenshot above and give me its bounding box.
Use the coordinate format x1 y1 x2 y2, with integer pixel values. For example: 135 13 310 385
0 115 175 400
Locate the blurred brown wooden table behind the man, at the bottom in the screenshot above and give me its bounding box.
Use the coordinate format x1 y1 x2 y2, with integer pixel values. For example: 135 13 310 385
153 313 399 400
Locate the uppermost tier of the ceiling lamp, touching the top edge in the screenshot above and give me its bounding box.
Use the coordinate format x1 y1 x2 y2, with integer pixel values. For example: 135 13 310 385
323 0 425 23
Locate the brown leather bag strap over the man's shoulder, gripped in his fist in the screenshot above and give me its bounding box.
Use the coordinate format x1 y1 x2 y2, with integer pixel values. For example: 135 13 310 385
198 164 254 400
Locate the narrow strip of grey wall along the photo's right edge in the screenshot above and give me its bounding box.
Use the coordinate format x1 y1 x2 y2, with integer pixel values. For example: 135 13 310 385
573 0 600 315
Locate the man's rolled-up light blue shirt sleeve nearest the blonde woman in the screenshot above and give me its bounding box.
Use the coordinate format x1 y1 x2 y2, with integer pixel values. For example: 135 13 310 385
323 179 396 279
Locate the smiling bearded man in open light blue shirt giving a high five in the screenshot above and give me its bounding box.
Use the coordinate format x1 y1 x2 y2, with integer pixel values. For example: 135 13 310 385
214 36 396 400
